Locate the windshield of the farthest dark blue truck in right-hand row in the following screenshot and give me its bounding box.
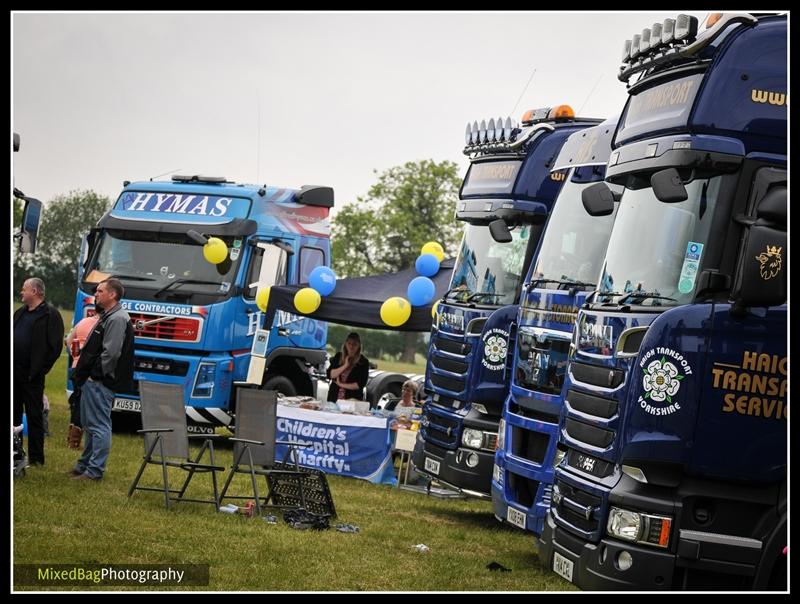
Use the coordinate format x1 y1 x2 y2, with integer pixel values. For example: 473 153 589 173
446 224 531 306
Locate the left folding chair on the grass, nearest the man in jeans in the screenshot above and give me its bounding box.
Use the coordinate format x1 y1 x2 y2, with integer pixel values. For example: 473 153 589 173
128 380 225 511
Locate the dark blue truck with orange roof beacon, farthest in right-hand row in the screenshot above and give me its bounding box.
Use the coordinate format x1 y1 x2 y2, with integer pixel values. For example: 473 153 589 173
412 105 600 498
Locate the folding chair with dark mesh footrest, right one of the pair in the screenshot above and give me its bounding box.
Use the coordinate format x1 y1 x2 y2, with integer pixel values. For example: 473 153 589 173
220 388 334 516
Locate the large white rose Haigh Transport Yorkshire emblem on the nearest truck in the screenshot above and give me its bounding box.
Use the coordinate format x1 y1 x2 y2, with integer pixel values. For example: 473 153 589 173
639 347 692 415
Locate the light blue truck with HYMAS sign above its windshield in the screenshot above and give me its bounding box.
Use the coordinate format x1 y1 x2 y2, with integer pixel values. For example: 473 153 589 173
68 175 333 432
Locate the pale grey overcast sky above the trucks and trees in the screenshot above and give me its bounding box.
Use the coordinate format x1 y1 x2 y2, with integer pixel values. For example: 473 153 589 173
11 11 706 214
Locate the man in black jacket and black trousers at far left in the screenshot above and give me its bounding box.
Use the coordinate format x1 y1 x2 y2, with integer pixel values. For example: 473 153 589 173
14 277 64 466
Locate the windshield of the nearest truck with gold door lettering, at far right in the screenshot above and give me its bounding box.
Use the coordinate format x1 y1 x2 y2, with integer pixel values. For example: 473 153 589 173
598 176 721 306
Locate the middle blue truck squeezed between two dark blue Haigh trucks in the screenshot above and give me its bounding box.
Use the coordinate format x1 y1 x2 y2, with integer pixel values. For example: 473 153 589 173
492 120 617 535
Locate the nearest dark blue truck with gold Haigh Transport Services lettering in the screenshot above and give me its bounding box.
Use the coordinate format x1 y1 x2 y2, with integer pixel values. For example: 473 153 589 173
539 14 788 590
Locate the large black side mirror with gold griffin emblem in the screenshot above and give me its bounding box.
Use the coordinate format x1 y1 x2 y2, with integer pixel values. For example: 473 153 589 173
731 168 788 307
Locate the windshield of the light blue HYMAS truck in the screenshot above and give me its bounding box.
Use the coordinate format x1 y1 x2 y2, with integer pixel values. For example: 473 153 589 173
86 230 242 299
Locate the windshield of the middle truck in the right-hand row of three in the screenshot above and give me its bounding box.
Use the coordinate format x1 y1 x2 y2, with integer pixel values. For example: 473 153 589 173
531 171 616 289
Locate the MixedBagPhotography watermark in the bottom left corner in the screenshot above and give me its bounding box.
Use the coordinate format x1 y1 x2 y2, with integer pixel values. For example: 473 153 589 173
14 564 208 587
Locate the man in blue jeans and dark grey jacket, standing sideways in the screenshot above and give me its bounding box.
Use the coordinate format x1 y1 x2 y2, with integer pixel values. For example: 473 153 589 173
69 279 133 480
